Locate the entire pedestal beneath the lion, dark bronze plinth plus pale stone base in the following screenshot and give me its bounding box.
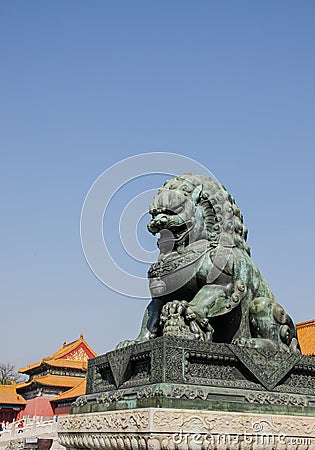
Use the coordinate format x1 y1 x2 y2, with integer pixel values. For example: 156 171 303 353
58 336 315 450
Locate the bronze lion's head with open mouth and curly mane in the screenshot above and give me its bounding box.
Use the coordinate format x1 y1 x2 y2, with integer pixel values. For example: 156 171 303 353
148 173 250 253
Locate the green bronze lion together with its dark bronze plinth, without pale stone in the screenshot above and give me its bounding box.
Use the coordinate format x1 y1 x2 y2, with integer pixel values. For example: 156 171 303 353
72 174 315 416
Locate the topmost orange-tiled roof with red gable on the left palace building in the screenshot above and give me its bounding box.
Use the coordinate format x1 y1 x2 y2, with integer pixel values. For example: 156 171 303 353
19 334 97 375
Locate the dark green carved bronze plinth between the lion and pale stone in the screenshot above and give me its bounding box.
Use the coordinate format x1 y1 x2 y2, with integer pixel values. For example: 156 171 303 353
78 336 315 417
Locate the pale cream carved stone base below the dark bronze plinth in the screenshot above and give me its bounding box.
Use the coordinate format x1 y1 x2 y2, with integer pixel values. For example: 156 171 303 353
58 408 315 450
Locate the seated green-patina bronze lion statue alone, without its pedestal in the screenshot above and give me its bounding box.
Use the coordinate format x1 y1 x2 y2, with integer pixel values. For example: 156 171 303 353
119 173 299 352
